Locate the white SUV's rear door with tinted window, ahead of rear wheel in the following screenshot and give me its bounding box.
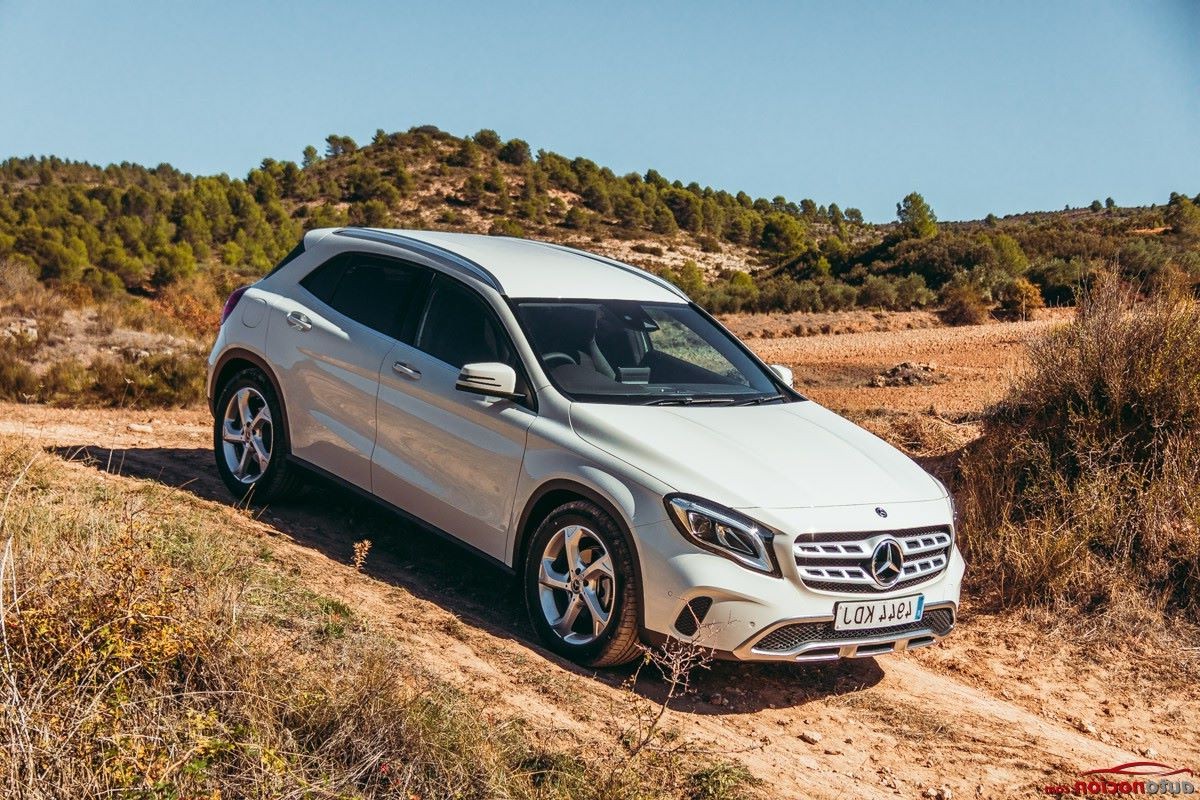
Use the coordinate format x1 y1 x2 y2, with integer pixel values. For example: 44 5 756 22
268 253 431 489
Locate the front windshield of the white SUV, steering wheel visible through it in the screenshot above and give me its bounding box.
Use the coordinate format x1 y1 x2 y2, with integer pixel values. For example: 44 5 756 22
516 300 791 405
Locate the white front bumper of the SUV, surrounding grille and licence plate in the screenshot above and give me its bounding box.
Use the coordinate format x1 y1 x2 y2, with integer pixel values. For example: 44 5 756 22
637 503 965 662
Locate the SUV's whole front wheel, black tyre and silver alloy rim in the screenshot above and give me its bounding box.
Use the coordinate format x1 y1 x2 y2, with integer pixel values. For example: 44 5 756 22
522 500 641 667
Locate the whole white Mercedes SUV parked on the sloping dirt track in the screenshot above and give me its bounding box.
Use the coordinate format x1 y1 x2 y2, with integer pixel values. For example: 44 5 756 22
208 228 964 667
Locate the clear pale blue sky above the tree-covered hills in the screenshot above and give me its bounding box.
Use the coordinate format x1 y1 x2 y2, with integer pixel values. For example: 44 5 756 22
0 0 1200 221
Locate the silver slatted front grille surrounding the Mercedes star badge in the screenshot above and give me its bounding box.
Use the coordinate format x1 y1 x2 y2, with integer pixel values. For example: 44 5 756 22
792 527 954 594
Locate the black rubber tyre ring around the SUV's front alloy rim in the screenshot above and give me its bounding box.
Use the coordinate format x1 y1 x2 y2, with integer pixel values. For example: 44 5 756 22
522 501 637 664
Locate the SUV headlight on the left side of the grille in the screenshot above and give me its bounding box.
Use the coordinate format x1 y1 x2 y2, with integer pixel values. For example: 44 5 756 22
666 494 780 577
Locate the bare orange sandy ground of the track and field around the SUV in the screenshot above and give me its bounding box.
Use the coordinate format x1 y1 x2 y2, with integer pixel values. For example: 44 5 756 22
0 311 1200 799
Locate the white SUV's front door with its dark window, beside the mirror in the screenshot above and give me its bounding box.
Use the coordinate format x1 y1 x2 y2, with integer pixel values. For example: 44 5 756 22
372 275 535 559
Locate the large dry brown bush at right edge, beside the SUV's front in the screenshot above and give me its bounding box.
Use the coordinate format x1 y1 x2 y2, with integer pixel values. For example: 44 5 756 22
958 279 1200 622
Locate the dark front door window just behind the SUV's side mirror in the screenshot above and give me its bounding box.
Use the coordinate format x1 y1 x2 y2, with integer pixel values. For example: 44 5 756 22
416 279 521 373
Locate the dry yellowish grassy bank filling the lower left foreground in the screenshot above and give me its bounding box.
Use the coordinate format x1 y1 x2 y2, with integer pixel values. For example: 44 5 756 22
0 439 744 800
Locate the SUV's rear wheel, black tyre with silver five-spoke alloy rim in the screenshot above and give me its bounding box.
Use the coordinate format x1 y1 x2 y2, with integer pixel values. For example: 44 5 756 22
212 368 300 505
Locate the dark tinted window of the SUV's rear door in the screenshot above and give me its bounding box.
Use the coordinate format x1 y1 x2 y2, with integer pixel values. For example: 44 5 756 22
300 253 428 338
